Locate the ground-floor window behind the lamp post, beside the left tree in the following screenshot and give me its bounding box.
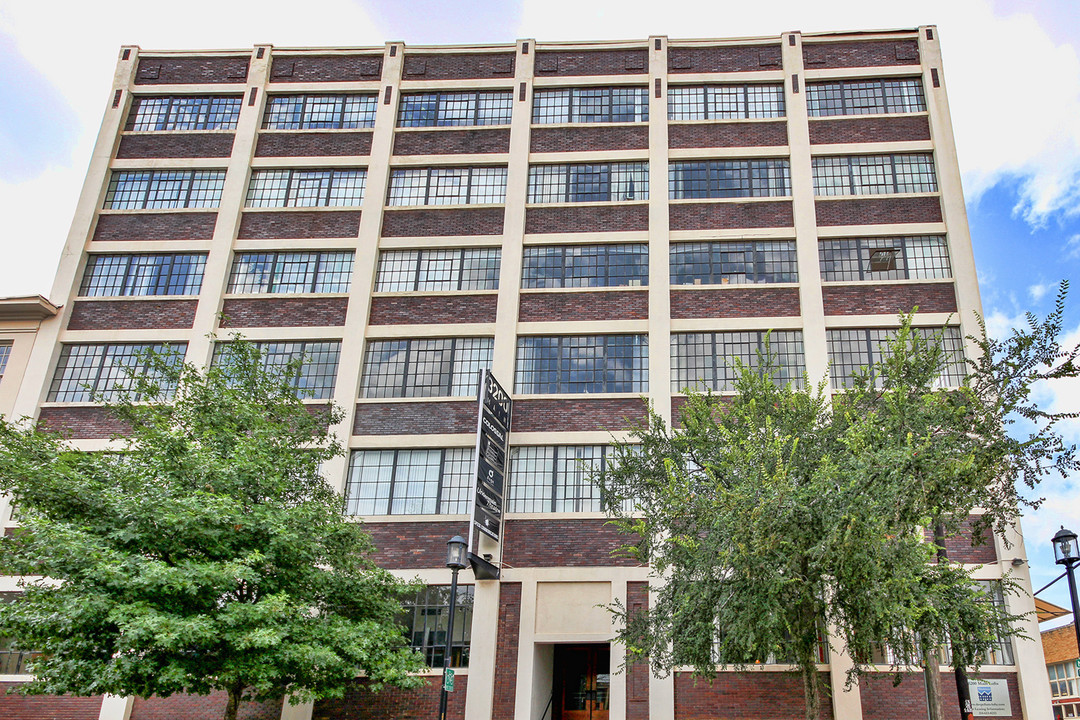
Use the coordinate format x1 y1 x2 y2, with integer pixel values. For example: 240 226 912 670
402 585 473 667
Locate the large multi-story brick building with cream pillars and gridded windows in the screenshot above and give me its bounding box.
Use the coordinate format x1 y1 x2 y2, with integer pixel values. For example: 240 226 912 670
0 26 1050 720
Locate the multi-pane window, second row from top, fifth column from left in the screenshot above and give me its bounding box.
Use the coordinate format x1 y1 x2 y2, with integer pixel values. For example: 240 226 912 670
667 160 792 200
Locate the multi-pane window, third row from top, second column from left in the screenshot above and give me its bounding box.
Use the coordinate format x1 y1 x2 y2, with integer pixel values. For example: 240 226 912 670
229 253 353 294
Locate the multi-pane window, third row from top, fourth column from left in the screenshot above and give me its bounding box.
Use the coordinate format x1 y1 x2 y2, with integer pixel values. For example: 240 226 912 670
522 244 649 287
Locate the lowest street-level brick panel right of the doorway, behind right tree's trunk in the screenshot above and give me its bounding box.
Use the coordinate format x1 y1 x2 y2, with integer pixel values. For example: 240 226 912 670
675 671 833 720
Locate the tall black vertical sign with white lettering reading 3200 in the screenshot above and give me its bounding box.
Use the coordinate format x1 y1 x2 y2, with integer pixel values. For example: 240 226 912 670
469 370 513 552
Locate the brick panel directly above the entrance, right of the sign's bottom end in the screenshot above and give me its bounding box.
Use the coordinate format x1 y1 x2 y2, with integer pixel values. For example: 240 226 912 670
498 518 640 568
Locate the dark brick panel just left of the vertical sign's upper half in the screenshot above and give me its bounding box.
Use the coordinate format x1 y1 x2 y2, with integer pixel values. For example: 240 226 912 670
352 399 477 435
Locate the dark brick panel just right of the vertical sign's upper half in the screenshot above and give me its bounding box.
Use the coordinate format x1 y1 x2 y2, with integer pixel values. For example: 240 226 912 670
511 396 646 433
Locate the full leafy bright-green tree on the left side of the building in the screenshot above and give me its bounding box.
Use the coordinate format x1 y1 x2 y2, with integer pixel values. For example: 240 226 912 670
0 338 423 720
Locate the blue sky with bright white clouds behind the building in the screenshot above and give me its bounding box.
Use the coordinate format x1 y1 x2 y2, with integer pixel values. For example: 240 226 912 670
0 0 1080 628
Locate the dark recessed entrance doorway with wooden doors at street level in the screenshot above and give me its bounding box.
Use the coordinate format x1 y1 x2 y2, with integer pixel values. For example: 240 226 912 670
553 642 611 720
